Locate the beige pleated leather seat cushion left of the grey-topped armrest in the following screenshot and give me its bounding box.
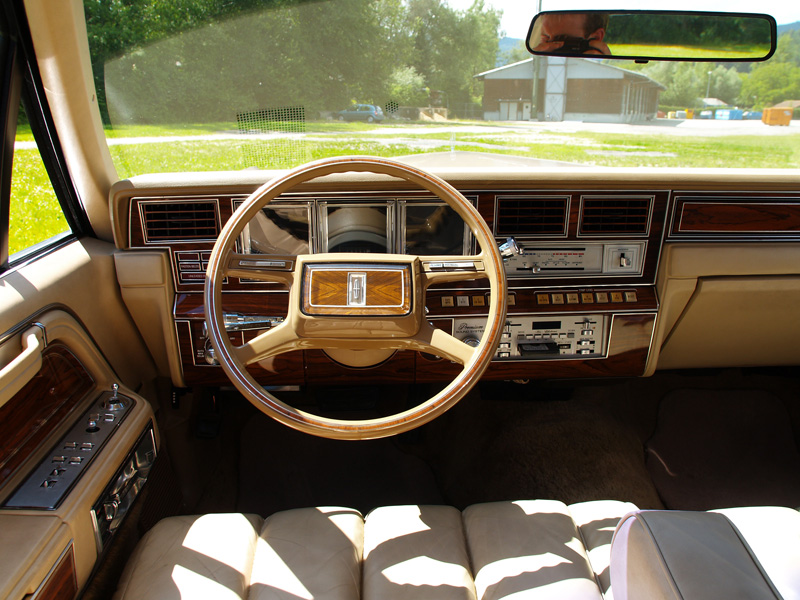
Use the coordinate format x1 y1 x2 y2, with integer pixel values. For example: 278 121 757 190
115 500 635 600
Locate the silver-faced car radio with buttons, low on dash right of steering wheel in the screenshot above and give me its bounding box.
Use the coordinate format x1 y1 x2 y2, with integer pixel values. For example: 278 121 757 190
453 315 611 360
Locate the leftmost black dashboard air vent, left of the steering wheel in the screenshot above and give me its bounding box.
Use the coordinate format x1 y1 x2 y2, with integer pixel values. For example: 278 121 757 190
141 200 219 243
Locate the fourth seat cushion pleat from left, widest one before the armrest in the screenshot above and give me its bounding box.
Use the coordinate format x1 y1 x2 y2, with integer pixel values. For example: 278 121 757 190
464 500 602 600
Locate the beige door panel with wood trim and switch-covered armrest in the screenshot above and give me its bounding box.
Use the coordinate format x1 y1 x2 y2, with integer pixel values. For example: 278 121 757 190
0 304 158 599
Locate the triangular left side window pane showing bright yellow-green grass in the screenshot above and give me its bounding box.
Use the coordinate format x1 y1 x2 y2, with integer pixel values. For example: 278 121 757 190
8 101 71 255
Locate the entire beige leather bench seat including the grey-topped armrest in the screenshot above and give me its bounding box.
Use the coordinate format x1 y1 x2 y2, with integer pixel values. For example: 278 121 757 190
115 500 800 600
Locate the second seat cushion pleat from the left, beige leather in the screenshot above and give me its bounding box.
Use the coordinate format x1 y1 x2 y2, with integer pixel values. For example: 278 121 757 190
249 508 364 600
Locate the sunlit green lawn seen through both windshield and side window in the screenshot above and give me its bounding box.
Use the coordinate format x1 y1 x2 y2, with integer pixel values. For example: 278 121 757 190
9 121 800 254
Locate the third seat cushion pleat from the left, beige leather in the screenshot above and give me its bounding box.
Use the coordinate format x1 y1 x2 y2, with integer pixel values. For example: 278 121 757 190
363 506 475 600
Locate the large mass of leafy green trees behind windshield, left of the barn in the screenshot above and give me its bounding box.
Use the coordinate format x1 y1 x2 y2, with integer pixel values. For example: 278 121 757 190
85 0 500 123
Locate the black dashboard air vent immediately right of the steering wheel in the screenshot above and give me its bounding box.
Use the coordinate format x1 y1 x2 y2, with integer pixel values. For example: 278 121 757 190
495 196 569 236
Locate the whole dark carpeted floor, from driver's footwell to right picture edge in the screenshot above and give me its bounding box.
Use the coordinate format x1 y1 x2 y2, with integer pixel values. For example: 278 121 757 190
195 370 800 515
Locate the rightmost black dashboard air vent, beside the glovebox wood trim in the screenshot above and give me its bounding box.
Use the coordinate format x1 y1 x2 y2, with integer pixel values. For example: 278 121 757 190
580 197 652 235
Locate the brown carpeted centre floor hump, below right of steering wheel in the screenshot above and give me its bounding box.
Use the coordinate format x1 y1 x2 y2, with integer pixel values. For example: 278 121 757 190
432 384 662 508
